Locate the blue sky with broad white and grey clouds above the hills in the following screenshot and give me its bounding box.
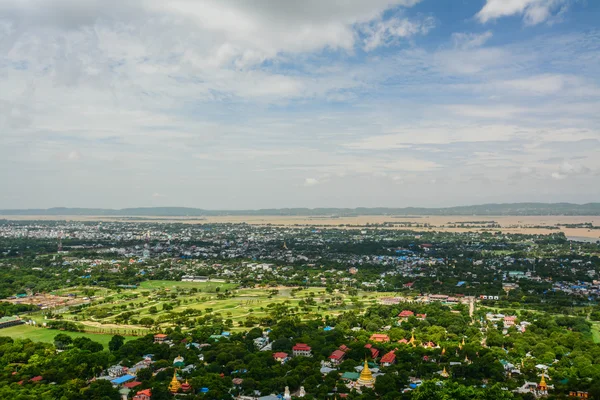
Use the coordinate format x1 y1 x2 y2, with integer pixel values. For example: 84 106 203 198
0 0 600 209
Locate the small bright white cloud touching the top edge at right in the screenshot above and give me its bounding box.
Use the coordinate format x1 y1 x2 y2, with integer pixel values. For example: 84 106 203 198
477 0 570 25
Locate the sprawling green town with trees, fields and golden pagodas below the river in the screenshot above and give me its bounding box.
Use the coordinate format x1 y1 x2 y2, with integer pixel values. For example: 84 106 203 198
0 221 600 400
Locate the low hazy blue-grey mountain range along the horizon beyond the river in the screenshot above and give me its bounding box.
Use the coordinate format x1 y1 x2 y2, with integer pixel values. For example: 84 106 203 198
0 203 600 217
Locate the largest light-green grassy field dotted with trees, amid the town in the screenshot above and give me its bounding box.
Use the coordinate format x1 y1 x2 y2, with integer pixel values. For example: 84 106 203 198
22 281 393 339
